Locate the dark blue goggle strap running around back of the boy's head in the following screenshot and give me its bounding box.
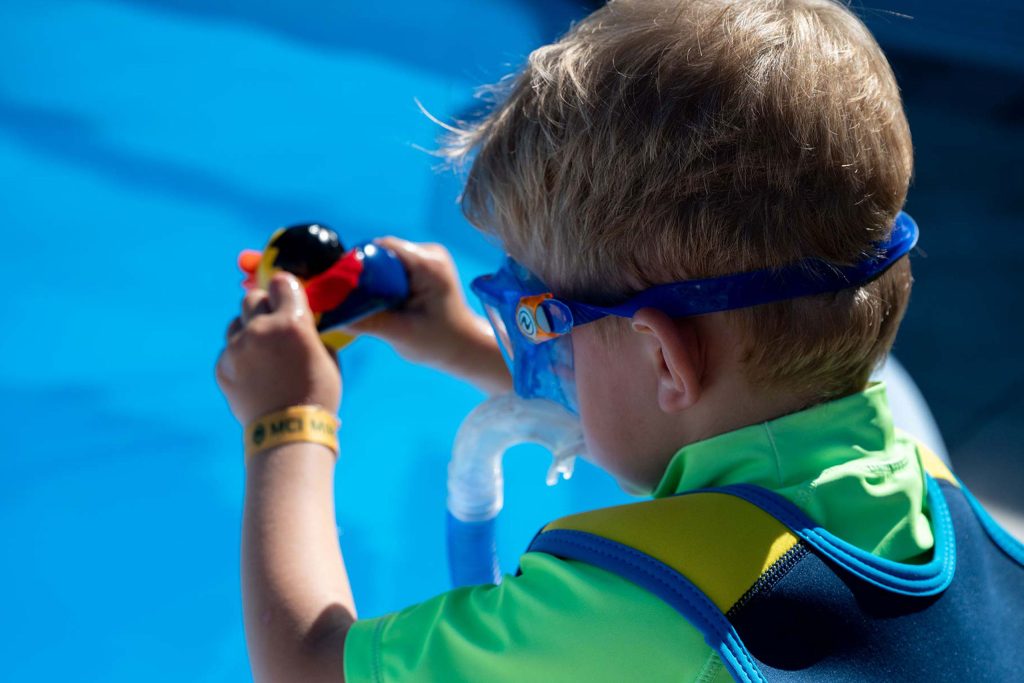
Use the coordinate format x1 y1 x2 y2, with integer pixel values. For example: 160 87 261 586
561 211 920 327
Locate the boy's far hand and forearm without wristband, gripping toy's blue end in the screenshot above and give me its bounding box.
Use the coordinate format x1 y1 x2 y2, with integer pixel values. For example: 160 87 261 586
351 238 512 393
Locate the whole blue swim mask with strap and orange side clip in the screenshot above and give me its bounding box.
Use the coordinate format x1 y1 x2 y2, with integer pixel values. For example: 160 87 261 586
470 212 919 415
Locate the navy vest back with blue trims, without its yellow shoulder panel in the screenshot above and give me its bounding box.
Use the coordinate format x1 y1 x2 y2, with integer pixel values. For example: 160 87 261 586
529 476 1024 683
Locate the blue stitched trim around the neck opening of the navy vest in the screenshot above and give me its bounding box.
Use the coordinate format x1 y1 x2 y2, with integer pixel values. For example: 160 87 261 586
693 476 954 596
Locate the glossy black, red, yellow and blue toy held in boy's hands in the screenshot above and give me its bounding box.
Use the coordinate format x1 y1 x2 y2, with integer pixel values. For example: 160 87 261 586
239 223 409 350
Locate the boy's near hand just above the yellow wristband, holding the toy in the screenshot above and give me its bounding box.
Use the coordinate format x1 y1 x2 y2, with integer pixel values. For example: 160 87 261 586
217 273 341 425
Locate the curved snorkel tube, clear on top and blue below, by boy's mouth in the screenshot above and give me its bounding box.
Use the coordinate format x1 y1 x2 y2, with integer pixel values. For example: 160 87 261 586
447 393 584 587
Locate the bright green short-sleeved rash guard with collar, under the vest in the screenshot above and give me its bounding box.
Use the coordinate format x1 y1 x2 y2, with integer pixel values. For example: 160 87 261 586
345 383 933 683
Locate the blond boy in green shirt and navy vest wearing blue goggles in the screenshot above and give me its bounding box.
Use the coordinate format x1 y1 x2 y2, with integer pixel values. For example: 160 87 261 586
217 0 1024 683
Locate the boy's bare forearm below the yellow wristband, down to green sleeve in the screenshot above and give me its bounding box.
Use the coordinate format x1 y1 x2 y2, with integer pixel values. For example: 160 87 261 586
242 443 356 683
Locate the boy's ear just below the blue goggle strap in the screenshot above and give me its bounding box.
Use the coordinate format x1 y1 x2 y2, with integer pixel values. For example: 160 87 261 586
632 308 705 413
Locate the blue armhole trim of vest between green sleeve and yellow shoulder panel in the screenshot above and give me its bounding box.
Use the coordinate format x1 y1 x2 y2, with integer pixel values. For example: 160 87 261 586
529 529 765 683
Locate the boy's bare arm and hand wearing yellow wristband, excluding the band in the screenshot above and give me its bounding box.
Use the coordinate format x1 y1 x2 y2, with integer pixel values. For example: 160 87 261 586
217 274 355 683
